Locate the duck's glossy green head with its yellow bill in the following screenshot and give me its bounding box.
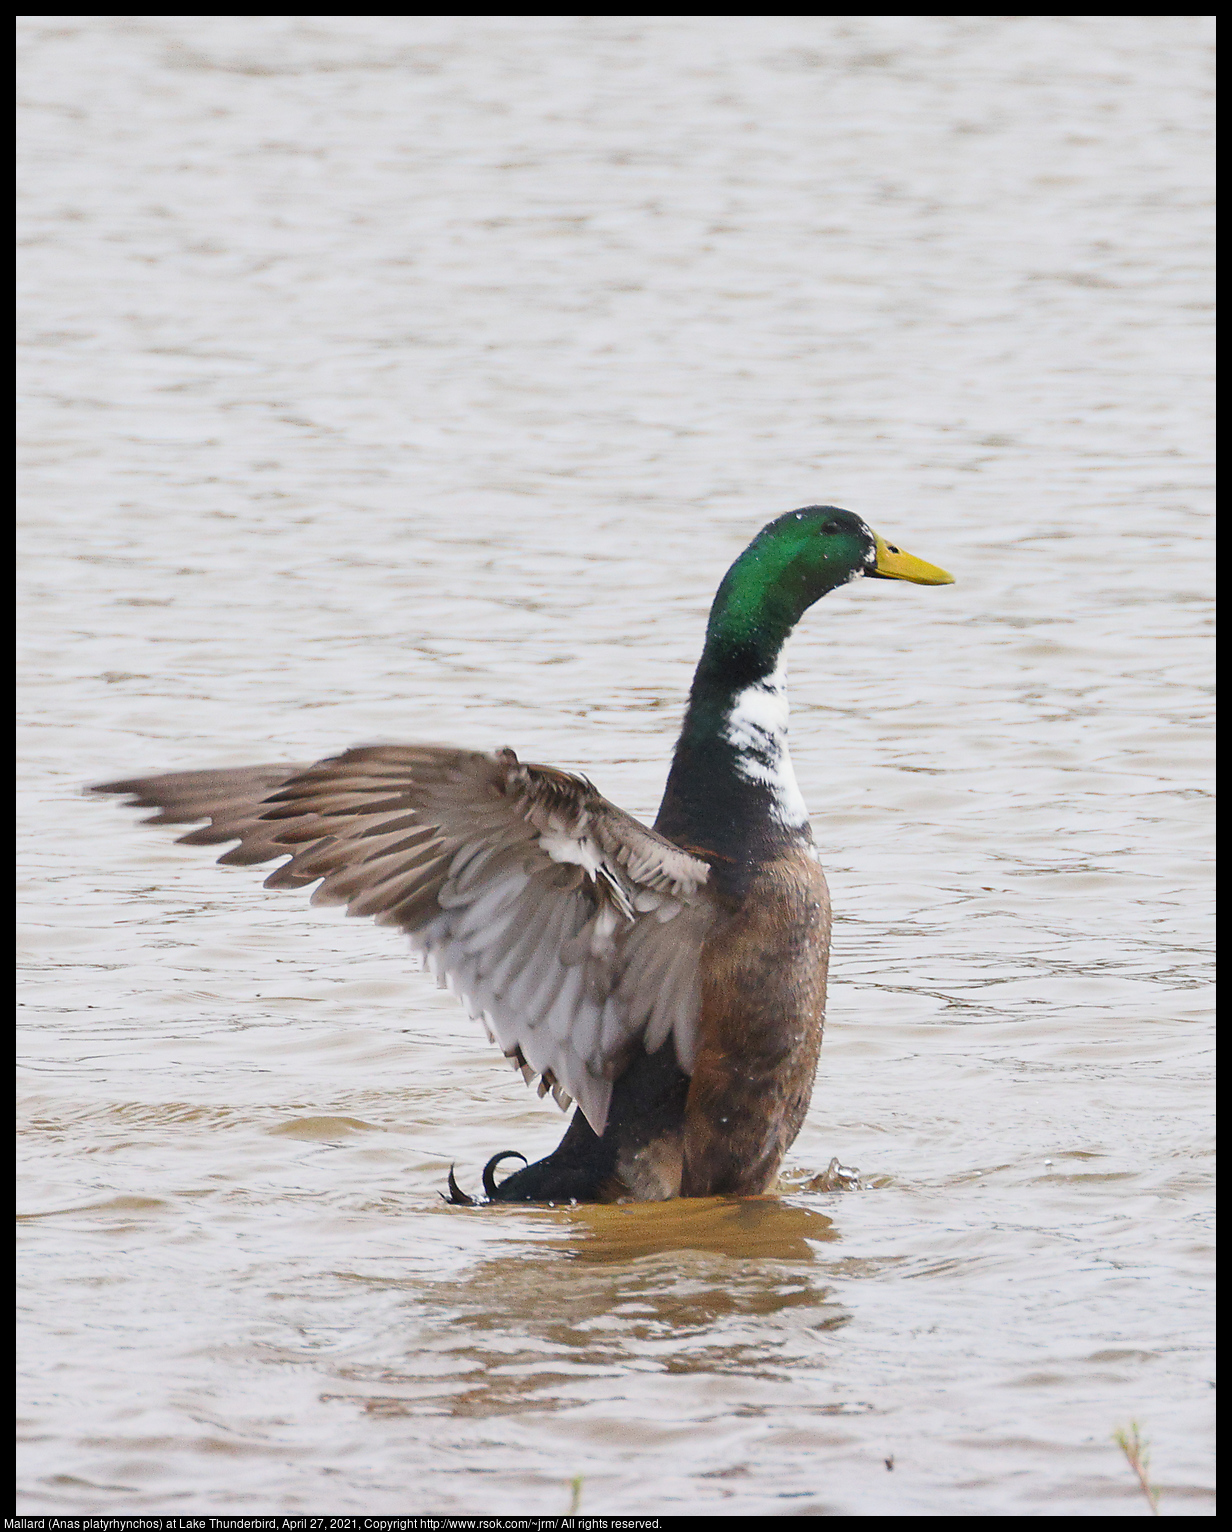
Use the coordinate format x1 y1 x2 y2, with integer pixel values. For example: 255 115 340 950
706 506 953 677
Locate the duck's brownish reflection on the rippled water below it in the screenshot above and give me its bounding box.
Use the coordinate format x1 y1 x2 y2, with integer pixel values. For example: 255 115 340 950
321 1196 849 1416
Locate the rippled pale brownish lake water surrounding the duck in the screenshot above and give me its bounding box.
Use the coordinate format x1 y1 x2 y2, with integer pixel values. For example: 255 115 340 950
18 17 1214 1515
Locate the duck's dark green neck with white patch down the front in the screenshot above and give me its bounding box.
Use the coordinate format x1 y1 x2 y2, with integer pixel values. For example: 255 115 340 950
656 559 812 889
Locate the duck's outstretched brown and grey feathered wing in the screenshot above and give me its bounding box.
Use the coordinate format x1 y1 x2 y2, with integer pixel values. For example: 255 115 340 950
93 745 717 1134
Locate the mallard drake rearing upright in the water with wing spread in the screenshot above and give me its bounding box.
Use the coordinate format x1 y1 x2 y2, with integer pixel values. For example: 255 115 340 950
93 506 952 1203
